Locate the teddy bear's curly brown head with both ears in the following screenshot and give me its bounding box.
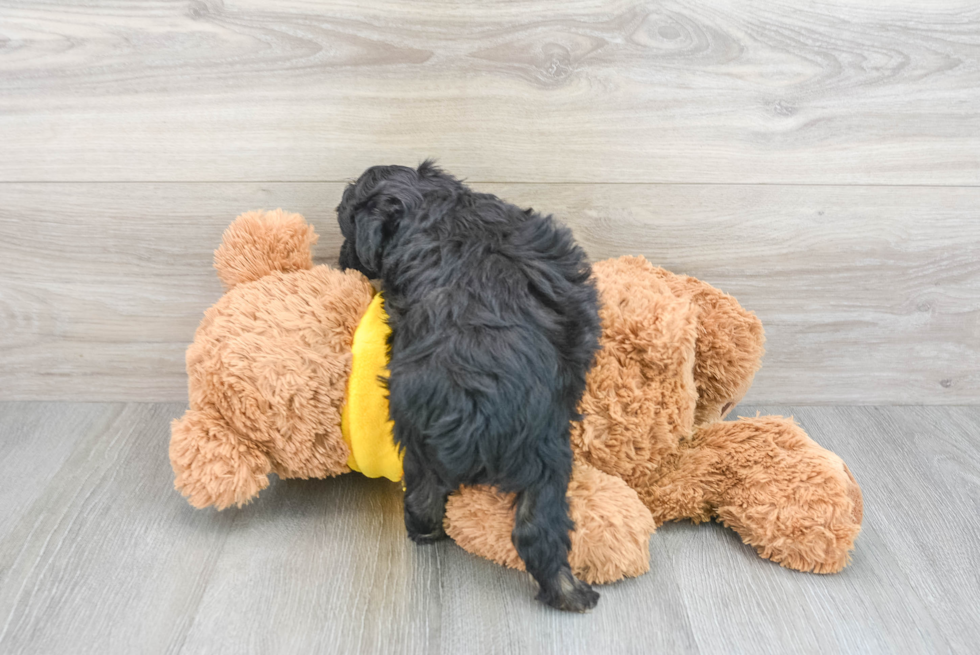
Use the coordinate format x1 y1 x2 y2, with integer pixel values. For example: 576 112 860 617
170 210 374 509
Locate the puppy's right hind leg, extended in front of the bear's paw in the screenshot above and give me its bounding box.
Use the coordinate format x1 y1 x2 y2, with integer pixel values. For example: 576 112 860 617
512 476 599 612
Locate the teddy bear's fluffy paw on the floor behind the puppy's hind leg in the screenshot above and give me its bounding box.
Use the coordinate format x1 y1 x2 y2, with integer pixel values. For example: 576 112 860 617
446 462 655 584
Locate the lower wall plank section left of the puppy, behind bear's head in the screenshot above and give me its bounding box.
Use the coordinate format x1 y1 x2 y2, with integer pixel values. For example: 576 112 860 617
0 184 339 402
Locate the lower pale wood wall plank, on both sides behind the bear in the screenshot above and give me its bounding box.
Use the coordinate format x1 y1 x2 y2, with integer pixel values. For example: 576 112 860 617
0 183 980 404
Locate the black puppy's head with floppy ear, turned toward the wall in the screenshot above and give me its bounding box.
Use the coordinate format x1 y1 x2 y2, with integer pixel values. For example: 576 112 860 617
337 161 439 279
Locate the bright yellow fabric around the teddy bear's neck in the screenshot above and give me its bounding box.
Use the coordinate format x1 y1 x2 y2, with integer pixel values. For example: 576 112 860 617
340 293 402 482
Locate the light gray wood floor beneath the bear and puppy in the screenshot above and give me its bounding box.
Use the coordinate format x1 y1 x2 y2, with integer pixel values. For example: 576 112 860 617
0 402 980 654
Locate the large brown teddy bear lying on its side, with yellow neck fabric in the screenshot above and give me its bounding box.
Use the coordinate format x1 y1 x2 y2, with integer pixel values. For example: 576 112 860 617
170 210 862 583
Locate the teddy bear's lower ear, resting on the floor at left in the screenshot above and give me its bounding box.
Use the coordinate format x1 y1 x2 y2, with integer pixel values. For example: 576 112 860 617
170 409 272 509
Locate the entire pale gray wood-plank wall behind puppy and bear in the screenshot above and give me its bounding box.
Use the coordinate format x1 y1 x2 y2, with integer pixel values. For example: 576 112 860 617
0 0 980 403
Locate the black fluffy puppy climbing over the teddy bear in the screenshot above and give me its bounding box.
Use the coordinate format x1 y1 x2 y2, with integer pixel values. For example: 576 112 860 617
337 162 599 612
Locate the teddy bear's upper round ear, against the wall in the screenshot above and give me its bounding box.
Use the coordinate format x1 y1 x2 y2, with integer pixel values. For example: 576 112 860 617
214 209 319 290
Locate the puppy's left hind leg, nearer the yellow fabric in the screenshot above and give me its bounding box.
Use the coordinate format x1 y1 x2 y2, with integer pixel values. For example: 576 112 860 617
403 448 452 544
